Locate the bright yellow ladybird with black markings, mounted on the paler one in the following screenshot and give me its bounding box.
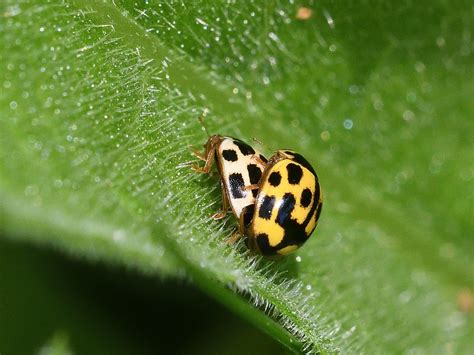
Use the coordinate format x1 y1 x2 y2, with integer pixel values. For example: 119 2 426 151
240 150 323 258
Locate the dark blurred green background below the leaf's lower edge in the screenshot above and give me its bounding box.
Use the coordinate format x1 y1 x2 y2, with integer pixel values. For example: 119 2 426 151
0 240 283 354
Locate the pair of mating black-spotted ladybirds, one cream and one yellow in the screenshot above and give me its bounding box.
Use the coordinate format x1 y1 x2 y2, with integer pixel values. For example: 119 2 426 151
193 135 323 258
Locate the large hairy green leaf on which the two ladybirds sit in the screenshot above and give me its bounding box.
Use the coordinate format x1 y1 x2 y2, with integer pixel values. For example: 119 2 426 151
0 0 474 353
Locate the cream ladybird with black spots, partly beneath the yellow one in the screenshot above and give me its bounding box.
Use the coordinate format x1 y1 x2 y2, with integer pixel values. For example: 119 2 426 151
193 135 267 219
